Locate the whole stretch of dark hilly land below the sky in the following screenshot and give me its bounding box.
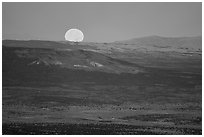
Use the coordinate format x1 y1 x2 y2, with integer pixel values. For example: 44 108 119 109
2 37 202 135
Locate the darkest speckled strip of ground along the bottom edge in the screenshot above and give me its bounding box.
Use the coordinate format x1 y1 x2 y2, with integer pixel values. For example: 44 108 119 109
3 123 202 135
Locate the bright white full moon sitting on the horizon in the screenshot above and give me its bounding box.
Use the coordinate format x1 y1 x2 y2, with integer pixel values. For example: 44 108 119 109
65 29 84 42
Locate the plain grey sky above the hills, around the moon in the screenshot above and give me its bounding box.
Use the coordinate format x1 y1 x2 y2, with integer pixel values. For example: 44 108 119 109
2 2 202 42
